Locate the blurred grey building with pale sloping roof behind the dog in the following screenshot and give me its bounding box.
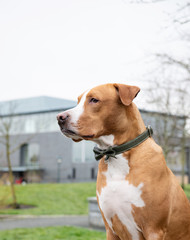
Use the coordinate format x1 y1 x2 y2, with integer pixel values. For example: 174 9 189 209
0 96 190 182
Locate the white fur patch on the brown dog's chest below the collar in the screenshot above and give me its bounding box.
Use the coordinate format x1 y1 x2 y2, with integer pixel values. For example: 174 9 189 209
97 154 145 240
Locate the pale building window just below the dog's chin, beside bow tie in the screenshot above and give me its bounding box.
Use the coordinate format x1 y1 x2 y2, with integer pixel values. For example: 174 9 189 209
73 141 95 163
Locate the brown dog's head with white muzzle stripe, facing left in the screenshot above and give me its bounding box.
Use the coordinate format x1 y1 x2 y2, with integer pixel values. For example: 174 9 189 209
57 84 140 141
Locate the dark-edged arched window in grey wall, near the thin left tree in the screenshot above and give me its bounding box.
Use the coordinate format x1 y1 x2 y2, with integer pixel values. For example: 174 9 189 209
20 143 39 166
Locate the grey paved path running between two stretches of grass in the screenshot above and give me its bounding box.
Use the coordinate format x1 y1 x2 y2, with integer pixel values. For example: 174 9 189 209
0 215 90 230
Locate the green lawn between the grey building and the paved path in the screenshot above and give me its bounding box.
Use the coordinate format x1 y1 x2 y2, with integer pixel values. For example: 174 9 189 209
0 182 96 215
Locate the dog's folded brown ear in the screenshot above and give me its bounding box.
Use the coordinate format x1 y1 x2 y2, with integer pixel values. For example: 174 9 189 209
114 83 140 106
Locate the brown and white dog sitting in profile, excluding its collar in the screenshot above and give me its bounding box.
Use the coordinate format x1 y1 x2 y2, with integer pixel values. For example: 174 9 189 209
57 84 190 240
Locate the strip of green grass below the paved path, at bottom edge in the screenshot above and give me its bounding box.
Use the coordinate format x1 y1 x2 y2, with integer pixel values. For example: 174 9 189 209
0 227 106 240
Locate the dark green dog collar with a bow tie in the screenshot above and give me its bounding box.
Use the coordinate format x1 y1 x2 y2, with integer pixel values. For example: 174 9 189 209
93 126 153 161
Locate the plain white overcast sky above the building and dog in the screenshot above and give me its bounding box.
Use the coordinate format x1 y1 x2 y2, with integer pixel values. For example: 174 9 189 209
0 0 187 109
